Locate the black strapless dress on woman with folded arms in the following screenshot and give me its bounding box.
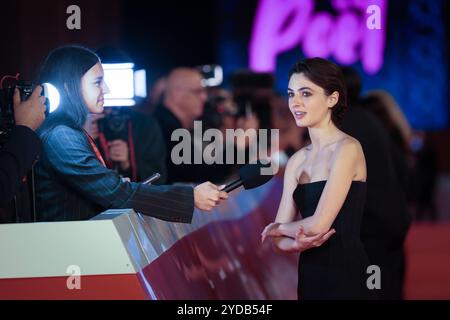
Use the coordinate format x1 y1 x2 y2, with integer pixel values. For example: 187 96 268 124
293 181 375 300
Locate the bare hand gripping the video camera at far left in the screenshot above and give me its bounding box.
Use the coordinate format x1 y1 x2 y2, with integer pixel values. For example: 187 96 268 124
13 86 45 131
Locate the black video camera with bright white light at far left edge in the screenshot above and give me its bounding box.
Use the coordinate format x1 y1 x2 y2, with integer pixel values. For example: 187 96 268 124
0 76 60 145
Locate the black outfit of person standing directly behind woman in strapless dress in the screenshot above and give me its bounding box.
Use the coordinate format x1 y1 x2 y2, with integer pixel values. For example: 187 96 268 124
342 106 411 300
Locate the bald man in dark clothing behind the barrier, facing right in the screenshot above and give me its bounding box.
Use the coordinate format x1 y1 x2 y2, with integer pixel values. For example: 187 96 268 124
154 68 227 183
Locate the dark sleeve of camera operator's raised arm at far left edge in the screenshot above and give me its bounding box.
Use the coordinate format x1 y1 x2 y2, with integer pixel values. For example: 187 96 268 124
0 126 42 204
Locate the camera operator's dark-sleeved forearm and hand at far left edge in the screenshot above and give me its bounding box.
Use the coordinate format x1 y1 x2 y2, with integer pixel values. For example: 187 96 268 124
0 86 45 204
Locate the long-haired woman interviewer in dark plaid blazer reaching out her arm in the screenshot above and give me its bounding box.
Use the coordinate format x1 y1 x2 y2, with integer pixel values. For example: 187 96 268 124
36 46 228 223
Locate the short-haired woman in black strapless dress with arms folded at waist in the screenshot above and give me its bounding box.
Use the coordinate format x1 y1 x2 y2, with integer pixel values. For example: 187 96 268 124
262 58 372 299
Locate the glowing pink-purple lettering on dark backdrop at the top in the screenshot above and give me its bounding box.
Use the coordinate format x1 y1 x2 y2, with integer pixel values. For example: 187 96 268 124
249 0 388 74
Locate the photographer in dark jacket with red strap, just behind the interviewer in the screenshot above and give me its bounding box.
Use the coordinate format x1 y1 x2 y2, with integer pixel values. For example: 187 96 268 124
84 107 167 185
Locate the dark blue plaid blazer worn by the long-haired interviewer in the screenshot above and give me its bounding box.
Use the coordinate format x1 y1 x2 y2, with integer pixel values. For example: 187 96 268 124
35 125 194 223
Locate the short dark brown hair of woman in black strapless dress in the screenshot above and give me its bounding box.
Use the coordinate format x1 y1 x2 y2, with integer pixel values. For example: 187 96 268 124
289 58 347 126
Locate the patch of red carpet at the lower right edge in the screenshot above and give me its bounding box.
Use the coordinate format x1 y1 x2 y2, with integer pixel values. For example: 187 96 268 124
405 223 450 300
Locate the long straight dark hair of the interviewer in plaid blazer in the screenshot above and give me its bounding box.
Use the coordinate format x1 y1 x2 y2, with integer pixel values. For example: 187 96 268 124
39 45 100 129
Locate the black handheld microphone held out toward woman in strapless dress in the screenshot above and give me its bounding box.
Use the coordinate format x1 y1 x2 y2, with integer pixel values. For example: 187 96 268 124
222 161 273 192
